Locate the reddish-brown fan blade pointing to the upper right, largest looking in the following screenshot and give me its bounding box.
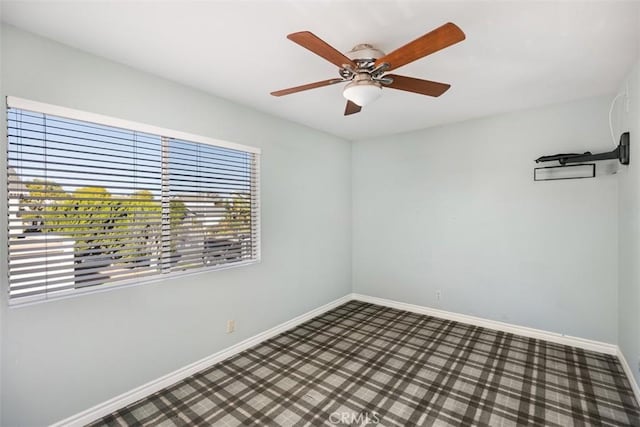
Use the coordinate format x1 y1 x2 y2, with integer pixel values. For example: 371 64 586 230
375 22 465 71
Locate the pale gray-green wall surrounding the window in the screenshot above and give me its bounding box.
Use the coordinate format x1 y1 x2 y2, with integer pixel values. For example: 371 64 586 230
0 27 351 426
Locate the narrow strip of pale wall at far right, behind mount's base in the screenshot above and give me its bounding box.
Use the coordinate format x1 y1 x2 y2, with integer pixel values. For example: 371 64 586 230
616 62 640 384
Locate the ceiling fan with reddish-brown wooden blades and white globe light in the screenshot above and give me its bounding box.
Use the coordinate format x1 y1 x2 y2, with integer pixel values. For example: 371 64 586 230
271 22 465 116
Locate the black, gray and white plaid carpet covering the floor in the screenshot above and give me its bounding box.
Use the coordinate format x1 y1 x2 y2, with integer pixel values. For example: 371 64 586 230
93 301 640 426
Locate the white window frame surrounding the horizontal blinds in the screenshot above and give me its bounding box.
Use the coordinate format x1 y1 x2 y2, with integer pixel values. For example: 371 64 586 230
4 96 262 307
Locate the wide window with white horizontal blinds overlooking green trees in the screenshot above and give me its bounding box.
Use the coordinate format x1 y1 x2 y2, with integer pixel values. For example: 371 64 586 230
7 97 260 304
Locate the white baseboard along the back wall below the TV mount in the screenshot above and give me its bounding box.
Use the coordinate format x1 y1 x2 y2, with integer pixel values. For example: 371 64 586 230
352 294 618 355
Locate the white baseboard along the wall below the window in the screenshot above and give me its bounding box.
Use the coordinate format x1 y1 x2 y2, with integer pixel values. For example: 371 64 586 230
52 294 353 427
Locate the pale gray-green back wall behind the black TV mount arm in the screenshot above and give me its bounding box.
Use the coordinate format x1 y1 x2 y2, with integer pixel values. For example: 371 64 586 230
352 94 618 343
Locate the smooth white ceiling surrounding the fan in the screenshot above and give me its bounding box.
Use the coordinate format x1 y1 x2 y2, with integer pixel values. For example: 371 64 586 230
2 0 640 139
